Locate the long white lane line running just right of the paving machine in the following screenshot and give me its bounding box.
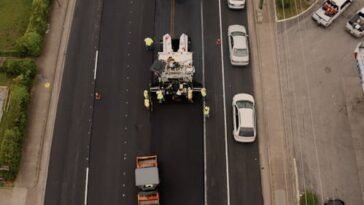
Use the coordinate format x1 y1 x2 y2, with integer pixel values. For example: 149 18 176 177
200 1 207 205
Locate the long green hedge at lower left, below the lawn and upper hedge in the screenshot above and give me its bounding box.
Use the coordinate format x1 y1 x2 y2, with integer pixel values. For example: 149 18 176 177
0 59 36 180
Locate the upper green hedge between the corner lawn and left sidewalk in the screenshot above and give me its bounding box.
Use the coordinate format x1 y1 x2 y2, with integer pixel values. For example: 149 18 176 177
16 0 50 57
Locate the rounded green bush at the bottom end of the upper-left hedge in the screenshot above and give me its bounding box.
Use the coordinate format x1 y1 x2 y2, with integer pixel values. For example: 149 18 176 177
15 32 43 57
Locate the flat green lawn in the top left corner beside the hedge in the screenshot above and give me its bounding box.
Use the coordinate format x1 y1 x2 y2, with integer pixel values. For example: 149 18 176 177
0 0 33 50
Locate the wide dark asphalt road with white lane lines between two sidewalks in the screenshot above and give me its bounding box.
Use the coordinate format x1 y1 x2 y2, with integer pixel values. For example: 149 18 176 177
45 0 263 205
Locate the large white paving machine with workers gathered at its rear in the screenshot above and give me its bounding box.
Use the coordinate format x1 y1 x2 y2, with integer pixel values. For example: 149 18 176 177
144 33 203 104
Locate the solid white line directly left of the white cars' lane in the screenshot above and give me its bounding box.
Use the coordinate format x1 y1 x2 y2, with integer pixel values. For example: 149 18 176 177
219 0 230 205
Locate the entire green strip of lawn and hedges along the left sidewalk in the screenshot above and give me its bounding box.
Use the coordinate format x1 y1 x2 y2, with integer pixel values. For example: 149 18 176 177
0 0 51 183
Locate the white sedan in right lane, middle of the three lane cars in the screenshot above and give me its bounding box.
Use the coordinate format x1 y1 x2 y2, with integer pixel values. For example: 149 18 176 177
228 25 249 66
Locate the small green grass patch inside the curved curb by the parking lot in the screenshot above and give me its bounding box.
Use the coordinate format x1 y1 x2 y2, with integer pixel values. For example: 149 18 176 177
276 0 315 20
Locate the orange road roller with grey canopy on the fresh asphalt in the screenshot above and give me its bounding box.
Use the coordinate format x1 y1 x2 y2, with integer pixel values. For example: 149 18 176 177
135 155 159 205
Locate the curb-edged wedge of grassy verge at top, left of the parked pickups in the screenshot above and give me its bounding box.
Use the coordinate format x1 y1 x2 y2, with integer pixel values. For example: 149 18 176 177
276 0 315 20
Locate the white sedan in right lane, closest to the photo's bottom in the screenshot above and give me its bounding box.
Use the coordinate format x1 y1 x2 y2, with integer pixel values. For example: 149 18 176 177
232 93 257 142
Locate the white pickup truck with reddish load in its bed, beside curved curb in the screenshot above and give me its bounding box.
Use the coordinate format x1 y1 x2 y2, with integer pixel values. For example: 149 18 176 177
312 0 353 27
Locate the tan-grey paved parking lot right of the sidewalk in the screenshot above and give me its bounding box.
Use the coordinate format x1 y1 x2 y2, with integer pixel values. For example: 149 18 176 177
276 1 364 204
